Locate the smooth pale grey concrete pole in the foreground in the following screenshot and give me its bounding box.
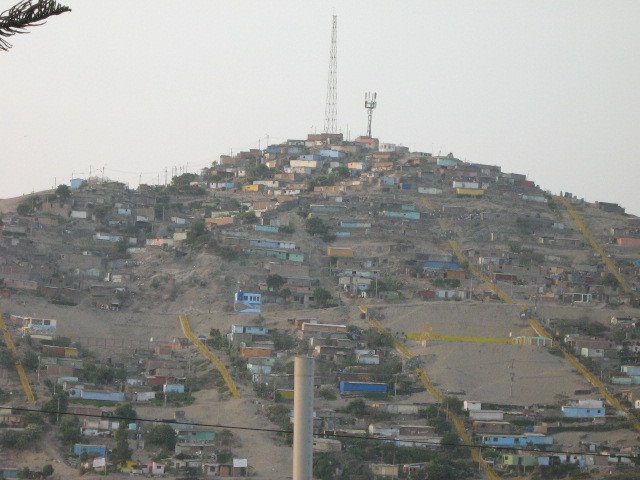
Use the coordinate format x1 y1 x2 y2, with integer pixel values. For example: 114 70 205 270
293 356 314 480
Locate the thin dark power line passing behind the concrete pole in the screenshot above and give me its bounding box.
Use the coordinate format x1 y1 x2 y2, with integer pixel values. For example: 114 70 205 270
7 407 640 459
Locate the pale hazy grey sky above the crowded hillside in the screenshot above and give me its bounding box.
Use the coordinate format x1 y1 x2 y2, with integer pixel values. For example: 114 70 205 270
0 0 640 214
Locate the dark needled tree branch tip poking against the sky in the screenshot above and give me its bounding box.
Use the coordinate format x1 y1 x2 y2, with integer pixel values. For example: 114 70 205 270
0 0 71 51
